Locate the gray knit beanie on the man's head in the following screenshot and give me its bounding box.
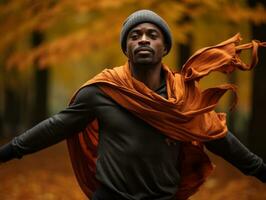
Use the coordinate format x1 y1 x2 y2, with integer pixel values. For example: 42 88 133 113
120 10 172 53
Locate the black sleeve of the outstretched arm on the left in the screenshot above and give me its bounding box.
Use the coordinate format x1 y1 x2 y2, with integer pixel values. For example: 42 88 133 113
0 86 97 162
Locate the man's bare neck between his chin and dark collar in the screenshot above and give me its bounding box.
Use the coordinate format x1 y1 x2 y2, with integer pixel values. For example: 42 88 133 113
129 62 162 90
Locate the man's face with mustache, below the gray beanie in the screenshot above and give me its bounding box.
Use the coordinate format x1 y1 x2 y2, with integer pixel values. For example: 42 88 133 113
126 23 167 65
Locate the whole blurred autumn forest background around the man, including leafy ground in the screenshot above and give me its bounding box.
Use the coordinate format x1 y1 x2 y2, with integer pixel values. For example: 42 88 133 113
0 0 266 200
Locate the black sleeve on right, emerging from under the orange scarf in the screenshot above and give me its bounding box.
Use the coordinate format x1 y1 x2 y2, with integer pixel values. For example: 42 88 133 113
205 132 266 182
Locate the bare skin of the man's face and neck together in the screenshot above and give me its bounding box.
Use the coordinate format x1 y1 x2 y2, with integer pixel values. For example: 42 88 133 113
126 23 167 90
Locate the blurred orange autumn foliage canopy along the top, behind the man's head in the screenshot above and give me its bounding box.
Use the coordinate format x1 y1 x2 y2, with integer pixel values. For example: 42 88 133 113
0 0 266 68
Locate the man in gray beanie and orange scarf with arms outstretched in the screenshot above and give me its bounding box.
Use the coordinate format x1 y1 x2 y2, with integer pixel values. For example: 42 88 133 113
0 10 266 200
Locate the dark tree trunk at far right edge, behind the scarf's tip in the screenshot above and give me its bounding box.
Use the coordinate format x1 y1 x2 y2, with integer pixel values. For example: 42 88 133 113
249 0 266 160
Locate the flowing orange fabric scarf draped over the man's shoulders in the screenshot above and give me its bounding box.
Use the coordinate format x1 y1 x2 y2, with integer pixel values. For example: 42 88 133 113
67 34 266 200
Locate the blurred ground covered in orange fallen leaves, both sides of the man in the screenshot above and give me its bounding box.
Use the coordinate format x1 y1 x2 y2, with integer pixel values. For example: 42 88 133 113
0 142 266 200
